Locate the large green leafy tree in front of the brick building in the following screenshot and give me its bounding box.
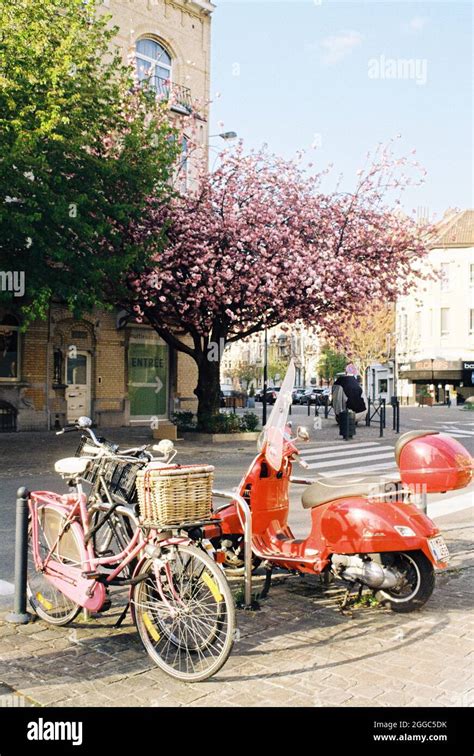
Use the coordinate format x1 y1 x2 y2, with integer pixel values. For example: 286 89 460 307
0 0 179 318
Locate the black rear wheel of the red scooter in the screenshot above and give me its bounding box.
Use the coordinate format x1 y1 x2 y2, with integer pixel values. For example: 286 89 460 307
376 551 435 613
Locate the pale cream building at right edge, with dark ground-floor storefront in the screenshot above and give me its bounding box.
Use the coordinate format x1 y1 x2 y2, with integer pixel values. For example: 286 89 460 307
397 210 474 403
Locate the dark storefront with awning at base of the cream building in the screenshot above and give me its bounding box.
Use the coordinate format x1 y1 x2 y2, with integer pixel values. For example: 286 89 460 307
399 358 474 404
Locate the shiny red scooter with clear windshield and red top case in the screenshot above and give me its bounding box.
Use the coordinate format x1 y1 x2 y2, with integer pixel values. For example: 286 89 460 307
215 363 473 612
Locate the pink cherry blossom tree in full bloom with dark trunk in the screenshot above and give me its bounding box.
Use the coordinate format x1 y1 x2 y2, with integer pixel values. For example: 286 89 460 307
122 139 434 430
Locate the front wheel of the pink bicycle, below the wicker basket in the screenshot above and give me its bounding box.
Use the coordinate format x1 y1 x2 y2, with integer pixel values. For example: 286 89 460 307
132 545 235 682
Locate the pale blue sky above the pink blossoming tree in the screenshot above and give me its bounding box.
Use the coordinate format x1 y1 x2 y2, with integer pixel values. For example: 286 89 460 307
210 0 474 219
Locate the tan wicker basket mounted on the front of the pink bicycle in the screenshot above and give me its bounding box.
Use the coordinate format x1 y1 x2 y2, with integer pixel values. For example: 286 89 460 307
136 465 214 527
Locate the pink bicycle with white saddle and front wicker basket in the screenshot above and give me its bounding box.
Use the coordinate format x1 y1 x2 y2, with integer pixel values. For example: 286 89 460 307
28 426 235 682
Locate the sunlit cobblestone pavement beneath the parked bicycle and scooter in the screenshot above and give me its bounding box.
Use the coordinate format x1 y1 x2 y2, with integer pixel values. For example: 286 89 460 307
0 513 474 707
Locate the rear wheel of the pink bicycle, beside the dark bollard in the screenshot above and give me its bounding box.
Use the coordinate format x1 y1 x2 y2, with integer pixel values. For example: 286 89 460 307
27 506 82 625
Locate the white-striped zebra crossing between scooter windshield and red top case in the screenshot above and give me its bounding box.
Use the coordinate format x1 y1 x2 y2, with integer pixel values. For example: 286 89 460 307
300 441 398 478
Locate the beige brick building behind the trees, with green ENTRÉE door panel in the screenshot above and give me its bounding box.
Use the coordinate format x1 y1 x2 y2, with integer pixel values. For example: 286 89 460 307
0 0 214 430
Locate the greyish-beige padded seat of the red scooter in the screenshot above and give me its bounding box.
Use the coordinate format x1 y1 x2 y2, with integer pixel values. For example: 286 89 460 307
302 473 401 509
